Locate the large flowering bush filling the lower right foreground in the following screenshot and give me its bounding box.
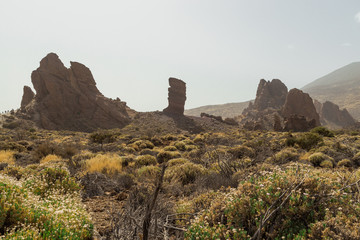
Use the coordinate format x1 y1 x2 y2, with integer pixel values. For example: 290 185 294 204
186 165 360 239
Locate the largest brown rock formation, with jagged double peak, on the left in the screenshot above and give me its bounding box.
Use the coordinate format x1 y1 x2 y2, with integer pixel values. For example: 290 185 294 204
23 53 131 131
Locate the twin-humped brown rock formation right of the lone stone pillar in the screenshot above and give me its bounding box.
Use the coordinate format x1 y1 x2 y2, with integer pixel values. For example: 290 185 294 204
238 79 320 131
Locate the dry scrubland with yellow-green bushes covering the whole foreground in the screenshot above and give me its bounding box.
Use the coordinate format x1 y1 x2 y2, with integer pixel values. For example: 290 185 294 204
0 124 360 239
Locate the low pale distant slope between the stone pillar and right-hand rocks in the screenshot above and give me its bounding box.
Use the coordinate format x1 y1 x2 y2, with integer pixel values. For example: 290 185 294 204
184 101 250 118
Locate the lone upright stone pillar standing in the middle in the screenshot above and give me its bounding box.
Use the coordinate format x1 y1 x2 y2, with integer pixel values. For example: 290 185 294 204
163 78 186 115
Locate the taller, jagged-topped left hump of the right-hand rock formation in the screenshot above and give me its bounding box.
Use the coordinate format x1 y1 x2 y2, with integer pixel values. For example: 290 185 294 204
254 79 288 111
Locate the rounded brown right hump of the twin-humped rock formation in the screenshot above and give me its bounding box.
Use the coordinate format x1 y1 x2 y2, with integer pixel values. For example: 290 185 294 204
282 88 320 126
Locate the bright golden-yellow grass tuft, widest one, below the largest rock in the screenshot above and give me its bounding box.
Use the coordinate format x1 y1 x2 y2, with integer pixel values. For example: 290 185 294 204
86 153 123 174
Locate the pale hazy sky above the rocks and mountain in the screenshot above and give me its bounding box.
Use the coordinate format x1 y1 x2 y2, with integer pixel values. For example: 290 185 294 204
0 0 360 111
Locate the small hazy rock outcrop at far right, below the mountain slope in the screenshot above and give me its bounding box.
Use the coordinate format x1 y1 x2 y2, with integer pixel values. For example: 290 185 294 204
320 101 356 127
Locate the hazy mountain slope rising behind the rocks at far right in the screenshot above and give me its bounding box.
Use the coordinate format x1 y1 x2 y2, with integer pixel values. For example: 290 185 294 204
302 62 360 120
